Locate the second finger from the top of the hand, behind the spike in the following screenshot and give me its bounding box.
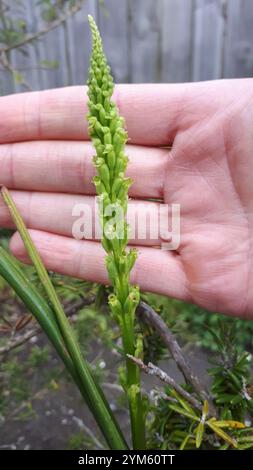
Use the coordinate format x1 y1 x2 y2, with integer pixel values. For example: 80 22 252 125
0 141 168 198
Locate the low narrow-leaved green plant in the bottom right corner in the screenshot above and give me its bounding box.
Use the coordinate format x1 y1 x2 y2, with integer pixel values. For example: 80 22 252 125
148 321 253 450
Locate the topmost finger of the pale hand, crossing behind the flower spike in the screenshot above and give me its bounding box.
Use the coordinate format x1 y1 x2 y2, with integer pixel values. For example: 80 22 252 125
0 84 192 145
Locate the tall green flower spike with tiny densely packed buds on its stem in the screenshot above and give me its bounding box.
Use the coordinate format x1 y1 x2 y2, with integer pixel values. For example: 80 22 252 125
88 12 145 449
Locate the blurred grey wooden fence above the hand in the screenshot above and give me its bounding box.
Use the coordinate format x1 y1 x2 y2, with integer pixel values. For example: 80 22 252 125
0 0 253 94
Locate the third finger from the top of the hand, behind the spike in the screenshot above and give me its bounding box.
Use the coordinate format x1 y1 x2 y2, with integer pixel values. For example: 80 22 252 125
0 191 168 246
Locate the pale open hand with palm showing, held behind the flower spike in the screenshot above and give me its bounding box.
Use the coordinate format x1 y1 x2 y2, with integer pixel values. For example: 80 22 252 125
0 79 253 318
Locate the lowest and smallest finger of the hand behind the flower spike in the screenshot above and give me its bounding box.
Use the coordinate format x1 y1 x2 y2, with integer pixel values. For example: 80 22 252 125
10 230 189 300
